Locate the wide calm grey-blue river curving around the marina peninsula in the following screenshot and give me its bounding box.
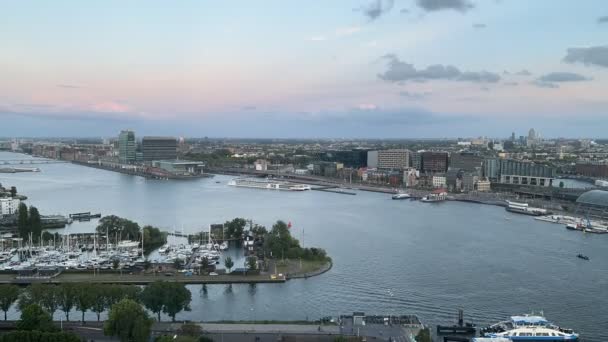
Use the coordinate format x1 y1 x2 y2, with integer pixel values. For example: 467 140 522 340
0 152 608 342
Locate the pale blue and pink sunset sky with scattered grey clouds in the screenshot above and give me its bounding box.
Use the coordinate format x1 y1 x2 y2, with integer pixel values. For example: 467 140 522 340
0 0 608 138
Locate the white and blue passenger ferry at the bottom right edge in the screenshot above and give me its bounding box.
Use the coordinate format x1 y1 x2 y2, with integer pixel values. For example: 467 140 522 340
480 315 578 342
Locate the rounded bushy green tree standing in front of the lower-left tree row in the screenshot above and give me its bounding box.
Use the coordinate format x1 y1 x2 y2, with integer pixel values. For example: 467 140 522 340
103 299 153 342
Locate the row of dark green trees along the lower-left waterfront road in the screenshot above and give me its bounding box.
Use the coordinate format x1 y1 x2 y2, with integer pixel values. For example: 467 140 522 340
0 281 192 323
